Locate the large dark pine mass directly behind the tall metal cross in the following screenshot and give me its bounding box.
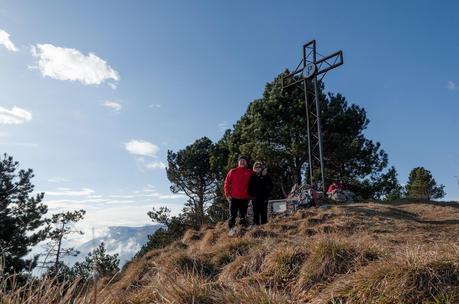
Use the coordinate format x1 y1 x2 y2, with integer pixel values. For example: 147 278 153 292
216 71 388 198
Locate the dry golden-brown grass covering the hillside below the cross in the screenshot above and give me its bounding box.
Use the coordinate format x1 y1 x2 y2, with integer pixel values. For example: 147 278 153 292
0 202 459 304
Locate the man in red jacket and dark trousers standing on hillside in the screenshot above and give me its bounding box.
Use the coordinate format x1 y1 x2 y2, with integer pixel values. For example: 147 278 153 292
225 155 253 235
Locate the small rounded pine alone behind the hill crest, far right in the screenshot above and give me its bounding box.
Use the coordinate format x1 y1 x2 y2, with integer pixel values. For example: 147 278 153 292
406 167 445 200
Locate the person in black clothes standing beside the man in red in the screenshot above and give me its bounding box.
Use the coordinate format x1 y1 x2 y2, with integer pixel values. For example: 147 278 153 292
249 161 273 225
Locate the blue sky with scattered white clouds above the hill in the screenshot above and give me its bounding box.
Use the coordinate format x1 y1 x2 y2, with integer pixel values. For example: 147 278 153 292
0 1 459 235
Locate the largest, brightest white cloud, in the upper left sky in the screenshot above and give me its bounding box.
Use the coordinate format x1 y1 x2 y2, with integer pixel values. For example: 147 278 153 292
32 44 119 85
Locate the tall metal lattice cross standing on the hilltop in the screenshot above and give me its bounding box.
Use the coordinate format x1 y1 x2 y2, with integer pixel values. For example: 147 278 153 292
282 40 344 193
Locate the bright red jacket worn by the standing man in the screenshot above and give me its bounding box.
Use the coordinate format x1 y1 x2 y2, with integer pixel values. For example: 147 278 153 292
225 167 253 199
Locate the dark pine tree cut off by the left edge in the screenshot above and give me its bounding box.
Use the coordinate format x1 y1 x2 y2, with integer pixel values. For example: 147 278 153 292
0 154 47 274
